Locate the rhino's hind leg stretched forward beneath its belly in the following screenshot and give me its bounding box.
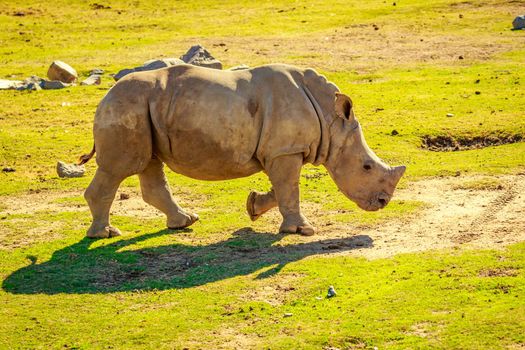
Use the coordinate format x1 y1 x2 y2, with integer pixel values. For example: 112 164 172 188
139 158 199 229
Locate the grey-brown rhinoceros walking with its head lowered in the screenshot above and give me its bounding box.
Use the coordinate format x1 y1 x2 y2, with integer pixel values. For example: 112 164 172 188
80 64 405 237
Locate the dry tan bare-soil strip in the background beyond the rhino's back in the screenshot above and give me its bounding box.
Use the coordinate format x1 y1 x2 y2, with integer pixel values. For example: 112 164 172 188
208 1 525 72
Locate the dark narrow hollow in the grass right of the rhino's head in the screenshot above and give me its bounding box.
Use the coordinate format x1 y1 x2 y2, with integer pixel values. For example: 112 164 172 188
421 134 524 152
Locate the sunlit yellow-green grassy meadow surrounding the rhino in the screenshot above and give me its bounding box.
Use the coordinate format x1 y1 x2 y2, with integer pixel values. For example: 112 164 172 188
0 0 525 349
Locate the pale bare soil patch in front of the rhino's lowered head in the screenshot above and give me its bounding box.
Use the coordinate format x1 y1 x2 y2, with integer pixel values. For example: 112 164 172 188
310 174 525 258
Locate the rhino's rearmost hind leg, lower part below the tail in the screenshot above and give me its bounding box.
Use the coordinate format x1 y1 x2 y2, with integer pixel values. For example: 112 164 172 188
84 168 124 238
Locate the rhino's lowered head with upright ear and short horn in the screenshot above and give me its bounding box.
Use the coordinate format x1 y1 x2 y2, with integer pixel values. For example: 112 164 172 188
324 93 406 211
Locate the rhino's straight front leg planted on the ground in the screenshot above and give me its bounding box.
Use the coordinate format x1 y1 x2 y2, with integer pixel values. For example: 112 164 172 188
266 154 314 236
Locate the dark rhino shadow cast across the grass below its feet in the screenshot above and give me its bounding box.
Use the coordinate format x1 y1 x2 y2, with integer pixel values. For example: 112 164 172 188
2 228 372 294
